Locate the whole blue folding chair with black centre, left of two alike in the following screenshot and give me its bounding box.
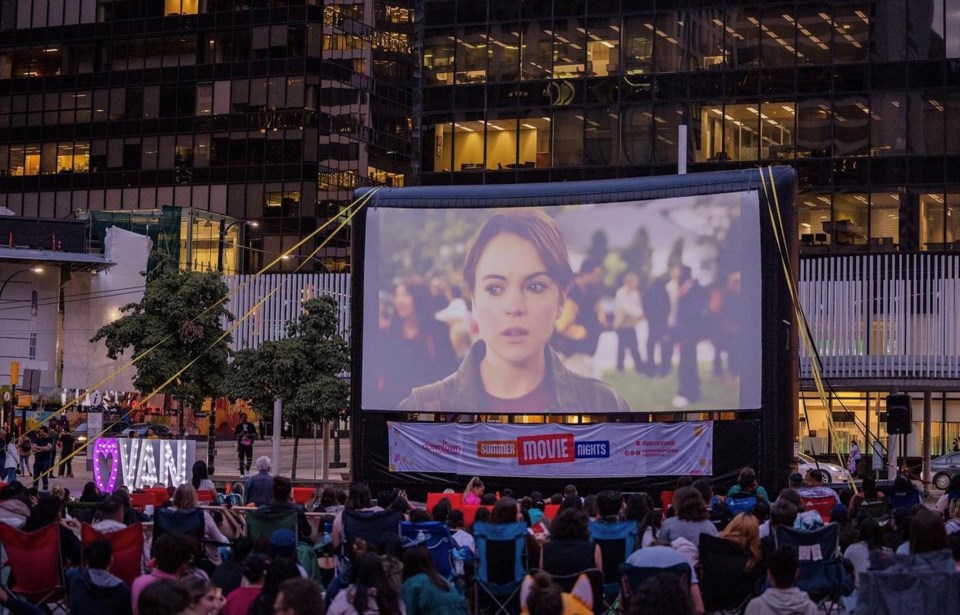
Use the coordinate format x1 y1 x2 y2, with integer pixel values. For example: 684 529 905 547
473 521 527 615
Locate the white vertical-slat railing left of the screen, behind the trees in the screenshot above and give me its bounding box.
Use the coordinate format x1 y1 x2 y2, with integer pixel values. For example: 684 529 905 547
224 273 350 350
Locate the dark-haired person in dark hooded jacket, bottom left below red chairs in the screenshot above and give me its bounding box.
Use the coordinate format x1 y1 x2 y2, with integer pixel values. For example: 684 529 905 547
70 538 132 615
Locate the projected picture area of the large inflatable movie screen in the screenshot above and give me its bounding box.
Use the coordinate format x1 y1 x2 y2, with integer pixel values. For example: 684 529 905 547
361 192 762 414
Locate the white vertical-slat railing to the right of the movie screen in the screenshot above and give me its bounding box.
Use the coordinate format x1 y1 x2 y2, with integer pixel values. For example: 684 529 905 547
800 253 960 380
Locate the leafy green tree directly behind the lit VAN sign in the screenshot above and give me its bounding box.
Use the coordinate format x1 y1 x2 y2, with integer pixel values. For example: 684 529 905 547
90 264 233 434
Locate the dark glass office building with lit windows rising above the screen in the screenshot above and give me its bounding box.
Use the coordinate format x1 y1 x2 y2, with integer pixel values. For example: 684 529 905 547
422 0 960 252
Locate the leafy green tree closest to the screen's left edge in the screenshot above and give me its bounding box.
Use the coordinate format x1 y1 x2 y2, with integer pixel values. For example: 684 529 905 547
223 297 350 478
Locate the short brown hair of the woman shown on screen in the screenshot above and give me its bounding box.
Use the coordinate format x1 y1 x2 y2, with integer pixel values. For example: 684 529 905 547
463 207 573 296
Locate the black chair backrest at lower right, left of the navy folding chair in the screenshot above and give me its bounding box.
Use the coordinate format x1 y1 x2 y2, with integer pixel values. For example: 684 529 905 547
700 534 757 611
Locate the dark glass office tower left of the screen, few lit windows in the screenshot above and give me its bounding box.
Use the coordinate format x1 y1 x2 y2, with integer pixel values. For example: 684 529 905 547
0 0 414 271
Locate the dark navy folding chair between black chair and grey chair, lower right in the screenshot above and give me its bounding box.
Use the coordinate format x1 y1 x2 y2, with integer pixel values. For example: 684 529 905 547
774 523 853 613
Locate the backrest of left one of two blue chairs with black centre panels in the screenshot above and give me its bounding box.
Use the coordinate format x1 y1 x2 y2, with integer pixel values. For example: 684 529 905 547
473 521 527 587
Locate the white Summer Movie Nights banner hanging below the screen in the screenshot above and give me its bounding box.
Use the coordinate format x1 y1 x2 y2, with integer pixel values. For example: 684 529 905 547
388 422 713 478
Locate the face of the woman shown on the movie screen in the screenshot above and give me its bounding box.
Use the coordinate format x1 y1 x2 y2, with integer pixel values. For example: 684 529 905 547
473 233 561 365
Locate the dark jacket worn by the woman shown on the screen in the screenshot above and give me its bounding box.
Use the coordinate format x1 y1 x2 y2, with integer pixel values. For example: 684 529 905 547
398 341 630 414
